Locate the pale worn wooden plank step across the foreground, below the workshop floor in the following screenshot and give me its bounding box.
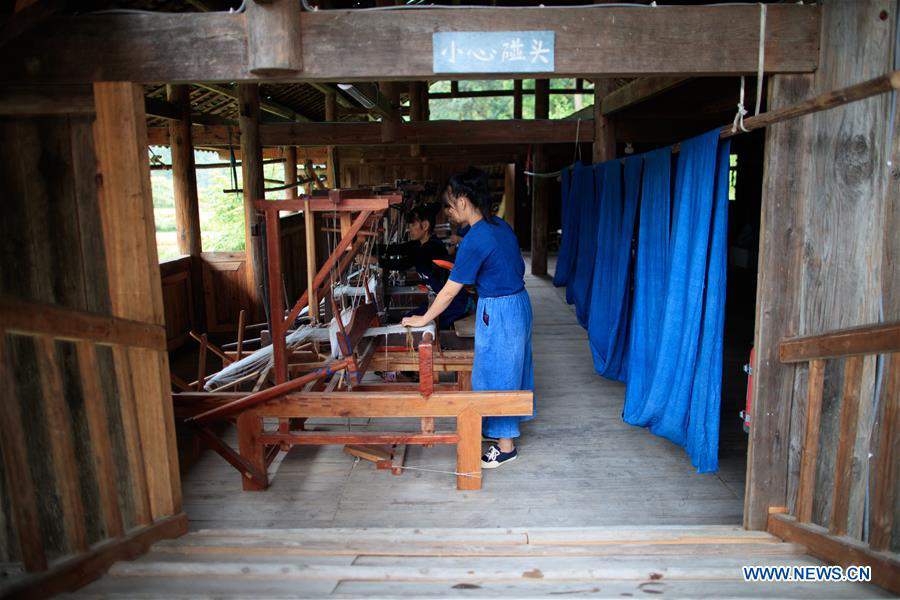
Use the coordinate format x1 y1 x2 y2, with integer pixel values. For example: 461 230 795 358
75 525 890 600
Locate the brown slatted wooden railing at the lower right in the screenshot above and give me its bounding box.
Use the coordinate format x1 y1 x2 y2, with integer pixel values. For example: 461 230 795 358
768 323 900 593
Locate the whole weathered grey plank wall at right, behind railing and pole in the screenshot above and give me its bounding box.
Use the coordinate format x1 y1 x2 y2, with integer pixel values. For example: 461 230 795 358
745 0 900 547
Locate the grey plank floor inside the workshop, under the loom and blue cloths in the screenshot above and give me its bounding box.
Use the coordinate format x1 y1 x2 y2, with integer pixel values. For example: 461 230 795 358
178 267 746 530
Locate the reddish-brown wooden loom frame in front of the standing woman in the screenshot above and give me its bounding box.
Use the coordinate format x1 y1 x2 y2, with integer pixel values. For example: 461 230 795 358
173 190 533 490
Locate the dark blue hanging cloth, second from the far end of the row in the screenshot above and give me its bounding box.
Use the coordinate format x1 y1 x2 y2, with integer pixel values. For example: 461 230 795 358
566 165 600 327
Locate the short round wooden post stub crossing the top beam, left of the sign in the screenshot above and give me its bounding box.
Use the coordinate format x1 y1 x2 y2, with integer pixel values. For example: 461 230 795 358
245 0 303 76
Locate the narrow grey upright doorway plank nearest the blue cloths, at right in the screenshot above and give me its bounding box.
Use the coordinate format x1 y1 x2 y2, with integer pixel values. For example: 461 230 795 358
744 75 814 529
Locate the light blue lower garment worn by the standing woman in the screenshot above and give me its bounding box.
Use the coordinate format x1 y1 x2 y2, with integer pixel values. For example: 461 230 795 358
472 290 534 438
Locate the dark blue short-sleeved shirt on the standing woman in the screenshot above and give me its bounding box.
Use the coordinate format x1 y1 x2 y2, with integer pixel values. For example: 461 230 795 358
450 217 525 298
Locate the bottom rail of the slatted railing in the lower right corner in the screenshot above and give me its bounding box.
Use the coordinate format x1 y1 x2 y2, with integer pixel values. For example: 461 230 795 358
768 514 900 594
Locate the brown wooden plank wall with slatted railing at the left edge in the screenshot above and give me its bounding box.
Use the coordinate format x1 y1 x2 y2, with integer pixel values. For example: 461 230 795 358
0 84 186 596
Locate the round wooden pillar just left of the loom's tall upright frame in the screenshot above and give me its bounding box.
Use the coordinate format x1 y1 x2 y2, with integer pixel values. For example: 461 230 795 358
238 83 265 315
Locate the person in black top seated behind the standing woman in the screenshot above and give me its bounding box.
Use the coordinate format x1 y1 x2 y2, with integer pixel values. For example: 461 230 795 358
380 205 469 329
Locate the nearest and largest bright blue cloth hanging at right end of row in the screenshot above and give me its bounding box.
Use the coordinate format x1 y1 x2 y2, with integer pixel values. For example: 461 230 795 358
629 130 730 473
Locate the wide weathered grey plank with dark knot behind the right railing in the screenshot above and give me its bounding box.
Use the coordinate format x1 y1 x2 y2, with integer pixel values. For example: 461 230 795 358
795 0 897 536
